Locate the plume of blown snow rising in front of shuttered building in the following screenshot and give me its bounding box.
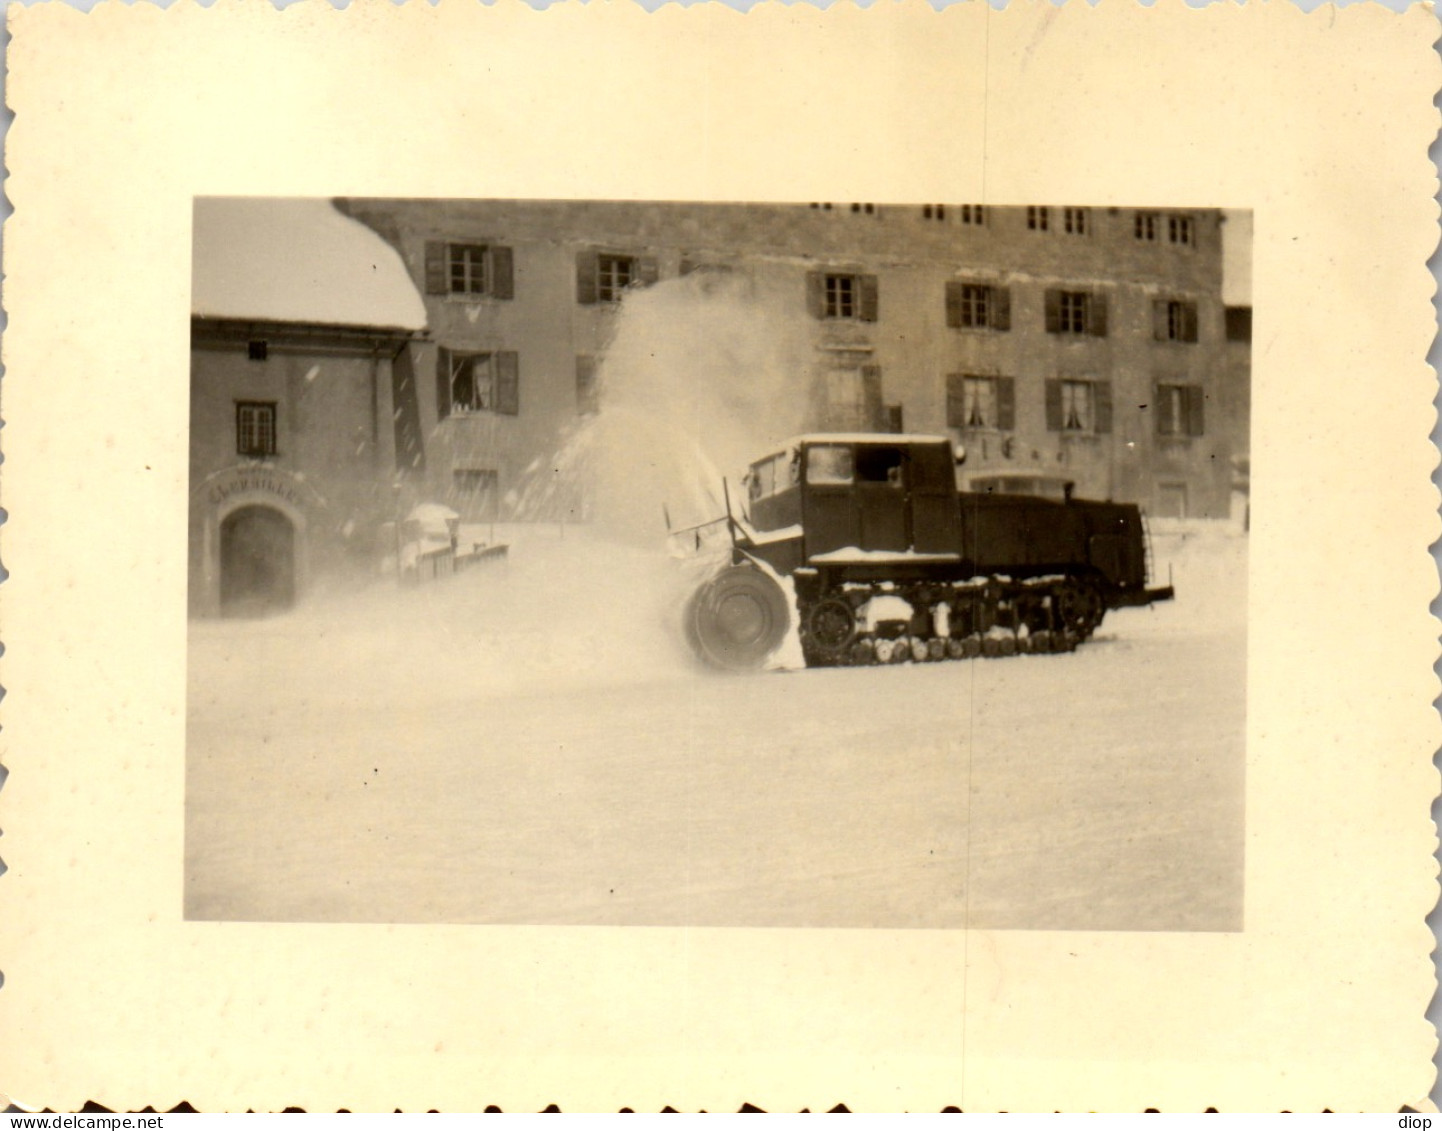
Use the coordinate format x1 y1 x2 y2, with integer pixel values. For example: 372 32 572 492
512 268 812 547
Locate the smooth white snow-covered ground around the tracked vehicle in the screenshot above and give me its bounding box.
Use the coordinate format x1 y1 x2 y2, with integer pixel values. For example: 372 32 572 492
186 527 1246 930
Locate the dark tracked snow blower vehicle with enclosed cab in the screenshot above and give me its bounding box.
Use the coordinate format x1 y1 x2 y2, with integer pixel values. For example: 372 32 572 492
671 433 1172 669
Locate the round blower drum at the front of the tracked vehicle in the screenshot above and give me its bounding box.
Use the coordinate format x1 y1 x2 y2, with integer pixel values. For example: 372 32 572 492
682 566 790 671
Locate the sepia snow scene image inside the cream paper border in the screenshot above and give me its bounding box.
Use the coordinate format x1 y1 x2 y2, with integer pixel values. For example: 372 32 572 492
185 196 1252 932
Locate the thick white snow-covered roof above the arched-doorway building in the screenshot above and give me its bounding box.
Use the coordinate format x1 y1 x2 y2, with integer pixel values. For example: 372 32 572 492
190 196 425 330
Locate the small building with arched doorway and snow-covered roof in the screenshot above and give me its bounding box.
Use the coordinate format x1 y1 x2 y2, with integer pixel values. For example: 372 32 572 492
189 199 425 616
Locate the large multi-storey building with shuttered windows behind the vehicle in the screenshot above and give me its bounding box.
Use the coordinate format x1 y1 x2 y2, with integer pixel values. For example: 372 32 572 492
336 199 1247 518
